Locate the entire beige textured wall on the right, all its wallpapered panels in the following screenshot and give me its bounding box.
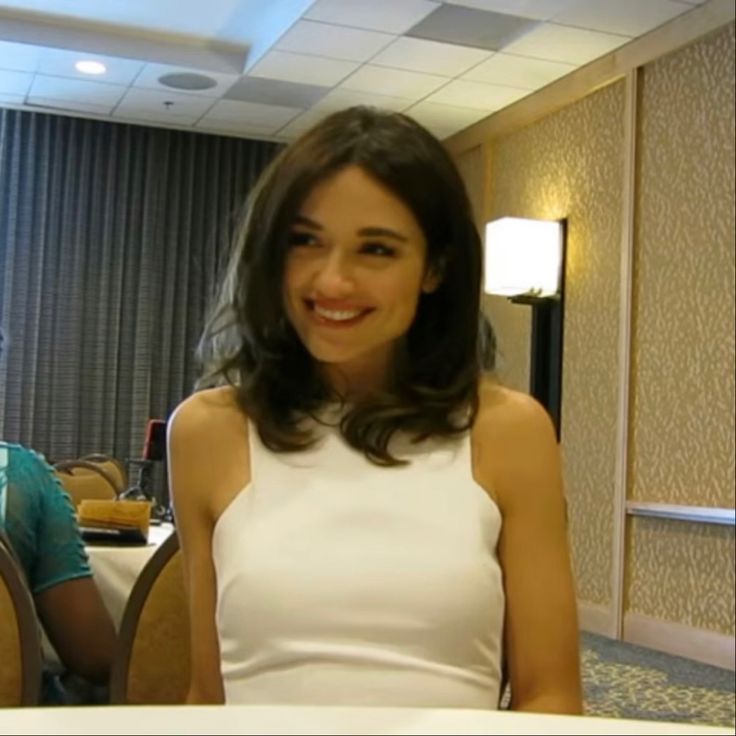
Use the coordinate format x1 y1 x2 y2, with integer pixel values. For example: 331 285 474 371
452 23 735 648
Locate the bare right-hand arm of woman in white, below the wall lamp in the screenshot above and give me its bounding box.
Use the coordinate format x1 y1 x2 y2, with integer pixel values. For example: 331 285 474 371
483 392 582 712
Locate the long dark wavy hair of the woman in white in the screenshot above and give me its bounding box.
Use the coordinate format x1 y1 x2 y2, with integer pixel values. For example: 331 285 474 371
197 107 495 465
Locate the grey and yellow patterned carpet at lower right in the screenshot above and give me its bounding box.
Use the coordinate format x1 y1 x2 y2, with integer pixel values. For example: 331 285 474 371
582 633 736 728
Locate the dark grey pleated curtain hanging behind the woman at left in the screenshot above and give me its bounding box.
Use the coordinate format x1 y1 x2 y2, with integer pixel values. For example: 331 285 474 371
0 110 278 468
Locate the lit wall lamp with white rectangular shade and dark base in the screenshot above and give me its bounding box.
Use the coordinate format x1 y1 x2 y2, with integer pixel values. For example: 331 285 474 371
485 217 567 440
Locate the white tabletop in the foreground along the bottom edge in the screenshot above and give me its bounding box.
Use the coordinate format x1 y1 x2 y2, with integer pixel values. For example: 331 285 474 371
0 705 736 736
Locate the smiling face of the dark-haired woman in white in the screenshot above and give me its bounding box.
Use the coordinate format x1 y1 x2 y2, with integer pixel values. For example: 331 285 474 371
284 166 436 391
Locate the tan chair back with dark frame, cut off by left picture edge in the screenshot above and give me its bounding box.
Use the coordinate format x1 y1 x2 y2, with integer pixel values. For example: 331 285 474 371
0 535 41 707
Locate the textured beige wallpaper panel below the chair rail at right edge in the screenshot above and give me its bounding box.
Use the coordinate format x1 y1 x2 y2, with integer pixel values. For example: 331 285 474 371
627 518 736 636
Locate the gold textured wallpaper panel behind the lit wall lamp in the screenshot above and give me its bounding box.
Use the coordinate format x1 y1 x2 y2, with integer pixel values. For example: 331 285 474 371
488 82 624 605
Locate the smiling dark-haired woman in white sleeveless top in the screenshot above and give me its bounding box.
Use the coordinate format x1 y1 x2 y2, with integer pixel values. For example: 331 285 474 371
169 108 581 713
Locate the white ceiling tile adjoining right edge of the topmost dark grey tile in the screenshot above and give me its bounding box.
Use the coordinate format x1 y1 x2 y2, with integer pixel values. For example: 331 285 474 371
504 23 629 64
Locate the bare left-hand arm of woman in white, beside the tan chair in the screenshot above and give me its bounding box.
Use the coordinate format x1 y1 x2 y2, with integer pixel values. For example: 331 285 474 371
168 392 250 703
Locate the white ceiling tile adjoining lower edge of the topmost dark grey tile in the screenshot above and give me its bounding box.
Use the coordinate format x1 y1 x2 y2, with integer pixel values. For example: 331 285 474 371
371 36 492 77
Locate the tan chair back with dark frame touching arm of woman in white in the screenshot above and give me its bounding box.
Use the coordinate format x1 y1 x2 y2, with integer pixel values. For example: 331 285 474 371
110 532 190 705
